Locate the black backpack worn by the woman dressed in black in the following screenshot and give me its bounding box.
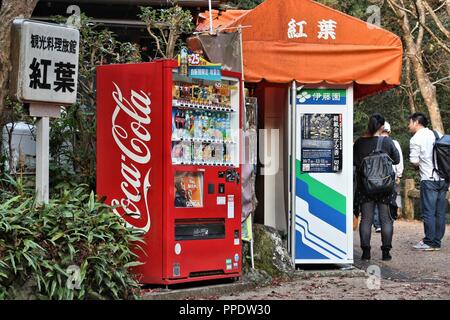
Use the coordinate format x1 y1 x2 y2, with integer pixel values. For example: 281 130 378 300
360 137 395 195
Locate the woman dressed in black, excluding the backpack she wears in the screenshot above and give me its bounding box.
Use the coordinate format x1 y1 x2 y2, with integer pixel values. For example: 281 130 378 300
353 113 400 260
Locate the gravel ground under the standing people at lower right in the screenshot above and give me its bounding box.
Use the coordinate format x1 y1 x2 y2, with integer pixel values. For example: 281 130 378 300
215 221 450 300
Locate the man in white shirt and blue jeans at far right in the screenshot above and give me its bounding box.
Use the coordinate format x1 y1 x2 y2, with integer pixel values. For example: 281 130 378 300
408 112 449 251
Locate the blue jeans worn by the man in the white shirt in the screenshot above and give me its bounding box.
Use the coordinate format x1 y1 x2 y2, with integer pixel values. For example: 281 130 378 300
420 180 448 248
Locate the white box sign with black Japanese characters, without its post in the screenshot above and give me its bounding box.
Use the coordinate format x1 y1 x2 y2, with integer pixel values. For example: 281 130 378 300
12 19 80 104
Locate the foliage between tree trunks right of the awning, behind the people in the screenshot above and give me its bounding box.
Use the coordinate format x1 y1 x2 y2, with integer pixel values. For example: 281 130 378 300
316 0 450 181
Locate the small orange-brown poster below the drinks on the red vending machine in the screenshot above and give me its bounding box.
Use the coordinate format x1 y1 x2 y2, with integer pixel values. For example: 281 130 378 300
175 171 203 208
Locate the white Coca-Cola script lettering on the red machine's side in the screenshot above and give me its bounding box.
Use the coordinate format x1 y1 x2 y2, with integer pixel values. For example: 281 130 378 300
111 82 151 232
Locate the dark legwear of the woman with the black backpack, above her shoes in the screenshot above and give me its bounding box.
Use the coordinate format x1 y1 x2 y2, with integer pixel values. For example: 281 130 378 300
359 201 394 250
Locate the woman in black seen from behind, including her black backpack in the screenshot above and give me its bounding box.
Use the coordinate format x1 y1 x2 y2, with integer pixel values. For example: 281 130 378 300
353 113 400 261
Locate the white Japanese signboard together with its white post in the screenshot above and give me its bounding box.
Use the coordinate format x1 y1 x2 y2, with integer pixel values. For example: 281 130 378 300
11 19 80 203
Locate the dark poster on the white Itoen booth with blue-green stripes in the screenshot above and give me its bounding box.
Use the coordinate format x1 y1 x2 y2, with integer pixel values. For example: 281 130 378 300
301 113 342 173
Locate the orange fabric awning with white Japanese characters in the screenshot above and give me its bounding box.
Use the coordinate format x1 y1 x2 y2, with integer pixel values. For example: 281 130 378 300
197 0 402 99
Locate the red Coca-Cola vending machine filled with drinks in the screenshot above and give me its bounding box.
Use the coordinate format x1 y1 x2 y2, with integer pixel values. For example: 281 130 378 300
97 60 242 285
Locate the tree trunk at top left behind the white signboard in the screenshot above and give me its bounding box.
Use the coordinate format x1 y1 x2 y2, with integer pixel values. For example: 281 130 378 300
0 0 38 115
